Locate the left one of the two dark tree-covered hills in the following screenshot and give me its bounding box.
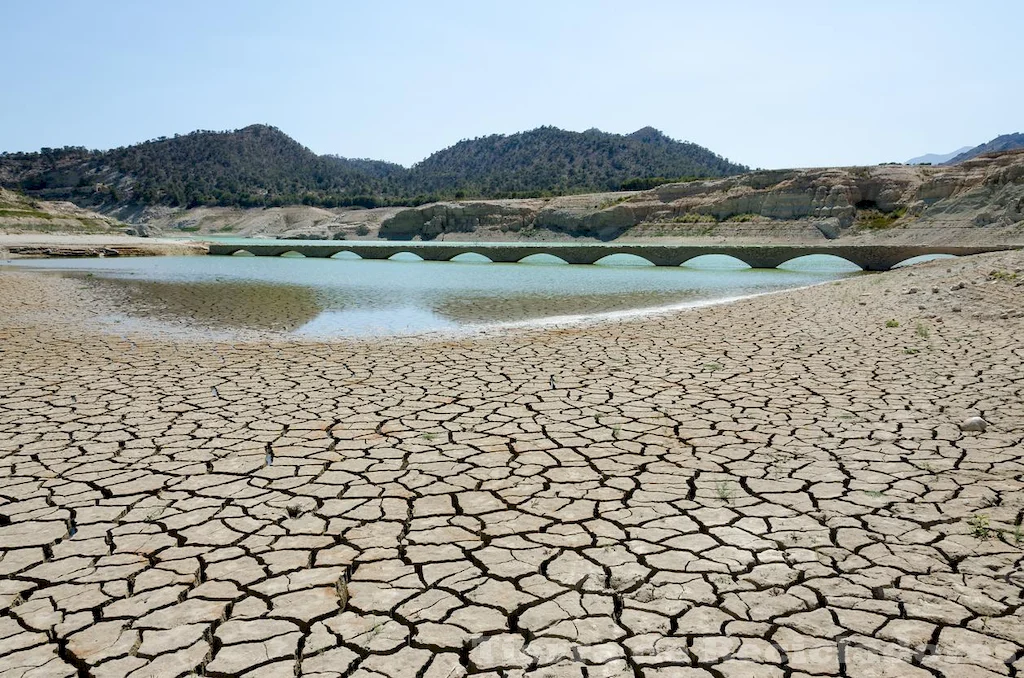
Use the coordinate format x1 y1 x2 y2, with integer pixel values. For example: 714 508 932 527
0 125 406 207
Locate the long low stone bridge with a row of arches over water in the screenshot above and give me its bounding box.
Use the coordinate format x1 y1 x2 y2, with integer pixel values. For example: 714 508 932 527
203 242 1014 270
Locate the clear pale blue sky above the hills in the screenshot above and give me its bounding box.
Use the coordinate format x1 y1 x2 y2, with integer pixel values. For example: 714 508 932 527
0 0 1024 167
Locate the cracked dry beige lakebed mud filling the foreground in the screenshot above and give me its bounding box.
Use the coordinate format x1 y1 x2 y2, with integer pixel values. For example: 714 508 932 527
0 253 1024 678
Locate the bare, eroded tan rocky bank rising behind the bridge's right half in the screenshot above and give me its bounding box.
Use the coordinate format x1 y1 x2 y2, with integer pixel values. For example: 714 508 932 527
378 151 1024 245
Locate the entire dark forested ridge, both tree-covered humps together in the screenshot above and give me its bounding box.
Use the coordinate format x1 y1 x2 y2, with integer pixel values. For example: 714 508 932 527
0 125 746 208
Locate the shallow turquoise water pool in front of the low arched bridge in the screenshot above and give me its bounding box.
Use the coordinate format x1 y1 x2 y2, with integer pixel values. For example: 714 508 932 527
5 250 856 337
